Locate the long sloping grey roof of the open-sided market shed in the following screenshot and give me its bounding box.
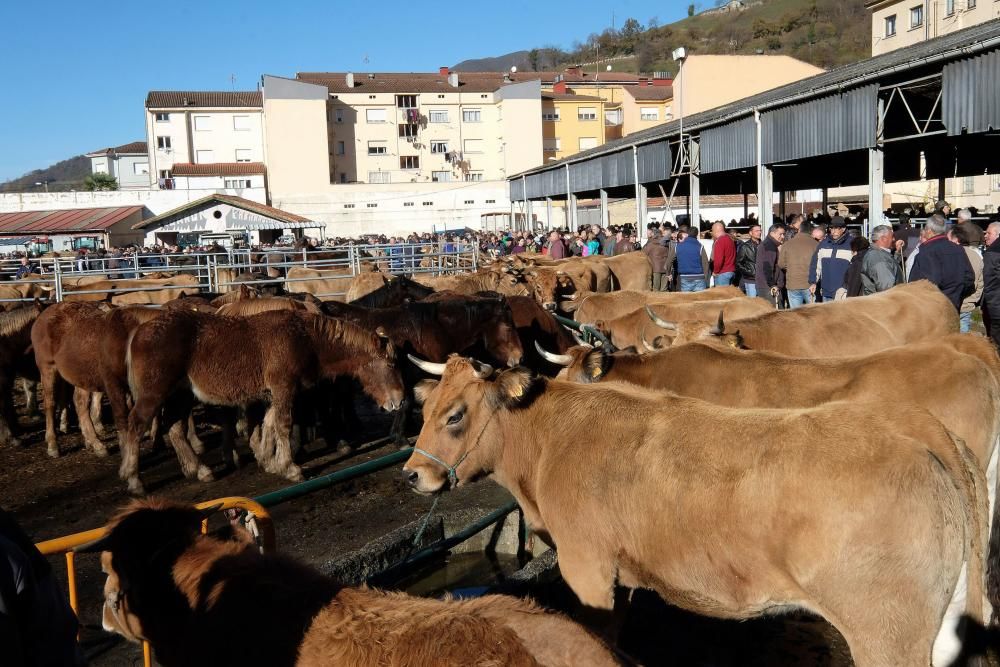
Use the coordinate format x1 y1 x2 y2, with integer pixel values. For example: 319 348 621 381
510 19 1000 179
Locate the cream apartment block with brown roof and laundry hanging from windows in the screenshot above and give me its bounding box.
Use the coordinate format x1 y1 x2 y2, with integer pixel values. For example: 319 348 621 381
296 68 542 185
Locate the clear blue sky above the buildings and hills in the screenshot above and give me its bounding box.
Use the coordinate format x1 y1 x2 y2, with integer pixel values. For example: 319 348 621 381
0 0 687 182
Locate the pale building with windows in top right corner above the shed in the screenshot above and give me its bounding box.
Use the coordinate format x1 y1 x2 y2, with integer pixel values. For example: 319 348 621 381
865 0 1000 56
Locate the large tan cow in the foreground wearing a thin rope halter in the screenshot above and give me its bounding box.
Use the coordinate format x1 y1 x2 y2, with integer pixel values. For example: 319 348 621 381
403 357 986 667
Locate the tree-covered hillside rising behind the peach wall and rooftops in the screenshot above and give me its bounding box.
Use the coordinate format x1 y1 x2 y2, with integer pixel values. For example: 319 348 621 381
455 0 871 73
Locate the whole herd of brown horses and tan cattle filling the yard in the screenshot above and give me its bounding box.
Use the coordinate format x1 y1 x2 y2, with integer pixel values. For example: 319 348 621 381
0 248 1000 667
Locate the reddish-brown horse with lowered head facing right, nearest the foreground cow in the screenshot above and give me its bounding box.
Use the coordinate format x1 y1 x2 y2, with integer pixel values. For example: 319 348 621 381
120 310 403 493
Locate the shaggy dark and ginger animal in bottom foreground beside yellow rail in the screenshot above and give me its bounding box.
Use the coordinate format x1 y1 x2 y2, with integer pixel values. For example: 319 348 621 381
78 499 617 667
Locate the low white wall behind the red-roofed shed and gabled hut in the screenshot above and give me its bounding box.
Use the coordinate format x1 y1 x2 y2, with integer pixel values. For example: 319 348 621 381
0 188 266 215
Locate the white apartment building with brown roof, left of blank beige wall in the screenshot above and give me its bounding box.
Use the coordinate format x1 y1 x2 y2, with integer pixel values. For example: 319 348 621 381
146 90 264 189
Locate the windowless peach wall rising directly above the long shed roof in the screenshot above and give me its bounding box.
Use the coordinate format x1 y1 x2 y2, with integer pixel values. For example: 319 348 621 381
673 56 824 118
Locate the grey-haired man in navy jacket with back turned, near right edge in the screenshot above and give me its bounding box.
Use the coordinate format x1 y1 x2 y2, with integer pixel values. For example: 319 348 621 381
910 213 976 312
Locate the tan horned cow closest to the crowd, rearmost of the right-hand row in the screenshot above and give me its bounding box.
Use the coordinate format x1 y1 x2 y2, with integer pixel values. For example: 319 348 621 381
647 280 958 357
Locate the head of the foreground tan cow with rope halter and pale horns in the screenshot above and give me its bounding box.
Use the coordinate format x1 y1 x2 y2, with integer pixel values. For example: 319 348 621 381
403 355 538 494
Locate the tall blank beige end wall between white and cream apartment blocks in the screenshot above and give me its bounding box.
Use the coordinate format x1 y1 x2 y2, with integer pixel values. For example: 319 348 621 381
263 75 330 198
